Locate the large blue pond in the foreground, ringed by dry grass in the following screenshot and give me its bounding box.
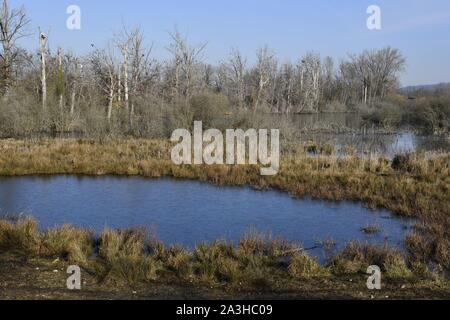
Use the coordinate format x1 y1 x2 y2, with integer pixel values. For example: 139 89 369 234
0 176 413 259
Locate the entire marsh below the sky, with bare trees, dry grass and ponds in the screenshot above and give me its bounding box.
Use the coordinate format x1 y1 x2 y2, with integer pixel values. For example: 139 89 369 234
0 0 450 299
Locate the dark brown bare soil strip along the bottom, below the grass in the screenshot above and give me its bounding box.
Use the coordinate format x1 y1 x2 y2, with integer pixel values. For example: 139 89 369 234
0 255 450 300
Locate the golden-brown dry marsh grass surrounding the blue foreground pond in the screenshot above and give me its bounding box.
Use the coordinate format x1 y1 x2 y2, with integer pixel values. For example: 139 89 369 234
0 140 450 298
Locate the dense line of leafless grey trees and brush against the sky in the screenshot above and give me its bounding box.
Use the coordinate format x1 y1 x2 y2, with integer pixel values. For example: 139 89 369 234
0 0 444 137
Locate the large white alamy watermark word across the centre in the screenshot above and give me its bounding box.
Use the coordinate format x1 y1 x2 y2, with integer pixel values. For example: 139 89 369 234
171 121 280 176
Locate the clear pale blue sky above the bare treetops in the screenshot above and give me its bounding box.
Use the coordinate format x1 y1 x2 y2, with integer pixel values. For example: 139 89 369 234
10 0 450 85
